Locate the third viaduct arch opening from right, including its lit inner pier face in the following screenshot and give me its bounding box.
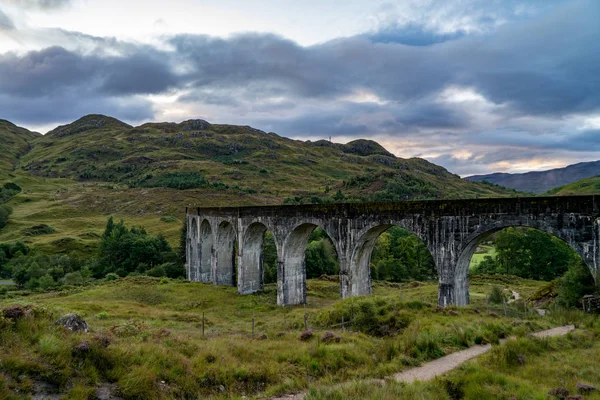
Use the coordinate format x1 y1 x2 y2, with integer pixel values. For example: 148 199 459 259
277 223 339 305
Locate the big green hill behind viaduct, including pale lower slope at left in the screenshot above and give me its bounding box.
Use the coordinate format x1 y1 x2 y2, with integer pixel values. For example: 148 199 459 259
0 115 515 252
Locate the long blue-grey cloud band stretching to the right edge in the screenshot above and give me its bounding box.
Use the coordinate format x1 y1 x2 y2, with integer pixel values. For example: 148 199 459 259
171 1 600 116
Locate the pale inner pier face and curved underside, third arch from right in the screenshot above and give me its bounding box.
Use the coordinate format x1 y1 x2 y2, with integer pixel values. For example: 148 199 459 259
277 222 339 305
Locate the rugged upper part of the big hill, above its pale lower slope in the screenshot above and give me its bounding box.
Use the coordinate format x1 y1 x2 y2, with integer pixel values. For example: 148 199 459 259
12 115 514 205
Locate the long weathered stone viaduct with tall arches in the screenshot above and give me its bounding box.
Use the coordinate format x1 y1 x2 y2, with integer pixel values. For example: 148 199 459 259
187 196 600 306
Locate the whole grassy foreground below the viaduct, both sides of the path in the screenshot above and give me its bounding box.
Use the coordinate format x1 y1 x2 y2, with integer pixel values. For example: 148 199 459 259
0 277 600 399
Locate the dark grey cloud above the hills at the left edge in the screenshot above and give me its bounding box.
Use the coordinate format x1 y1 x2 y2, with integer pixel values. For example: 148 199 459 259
0 47 177 125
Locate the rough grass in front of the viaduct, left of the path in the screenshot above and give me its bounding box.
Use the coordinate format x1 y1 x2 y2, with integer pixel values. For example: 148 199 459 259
0 277 556 399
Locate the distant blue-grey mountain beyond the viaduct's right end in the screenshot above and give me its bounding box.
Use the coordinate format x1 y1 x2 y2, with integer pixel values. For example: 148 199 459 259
465 161 600 194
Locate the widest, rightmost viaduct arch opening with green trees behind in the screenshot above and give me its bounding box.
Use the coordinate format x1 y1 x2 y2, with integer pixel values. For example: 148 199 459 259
455 225 597 306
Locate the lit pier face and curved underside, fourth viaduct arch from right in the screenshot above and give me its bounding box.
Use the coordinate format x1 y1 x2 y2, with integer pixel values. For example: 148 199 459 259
238 222 277 294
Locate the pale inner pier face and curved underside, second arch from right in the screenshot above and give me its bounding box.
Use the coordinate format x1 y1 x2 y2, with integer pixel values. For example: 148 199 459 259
347 221 431 296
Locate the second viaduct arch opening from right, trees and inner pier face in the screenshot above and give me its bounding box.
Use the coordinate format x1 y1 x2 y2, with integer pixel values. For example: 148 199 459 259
349 224 437 296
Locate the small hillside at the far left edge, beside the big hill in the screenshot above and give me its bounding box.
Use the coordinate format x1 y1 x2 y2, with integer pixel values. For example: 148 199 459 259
0 119 41 178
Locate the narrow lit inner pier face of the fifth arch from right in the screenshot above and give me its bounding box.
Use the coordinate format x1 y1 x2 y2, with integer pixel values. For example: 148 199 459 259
214 221 236 286
